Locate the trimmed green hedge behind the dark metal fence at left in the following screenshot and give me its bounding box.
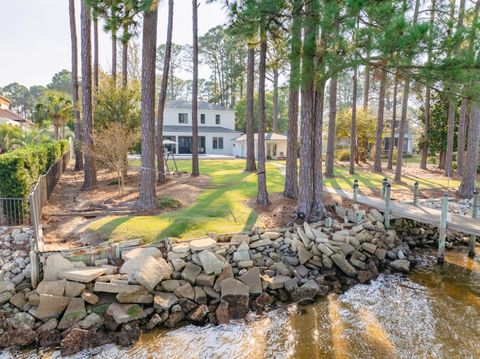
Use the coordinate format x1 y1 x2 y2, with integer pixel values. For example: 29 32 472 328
0 140 69 198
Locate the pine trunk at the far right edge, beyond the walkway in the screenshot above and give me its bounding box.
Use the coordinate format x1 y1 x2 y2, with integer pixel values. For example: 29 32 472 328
458 102 480 198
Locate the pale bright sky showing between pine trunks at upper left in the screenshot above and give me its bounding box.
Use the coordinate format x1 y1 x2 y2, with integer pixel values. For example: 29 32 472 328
0 0 227 87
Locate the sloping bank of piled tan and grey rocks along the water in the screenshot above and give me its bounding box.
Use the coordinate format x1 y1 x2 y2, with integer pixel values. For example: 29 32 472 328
0 206 470 355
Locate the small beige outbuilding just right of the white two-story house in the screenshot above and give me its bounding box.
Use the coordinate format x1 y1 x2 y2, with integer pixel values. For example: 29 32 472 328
233 133 287 160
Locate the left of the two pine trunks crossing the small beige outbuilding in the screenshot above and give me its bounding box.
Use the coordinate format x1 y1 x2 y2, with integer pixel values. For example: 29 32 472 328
245 43 257 172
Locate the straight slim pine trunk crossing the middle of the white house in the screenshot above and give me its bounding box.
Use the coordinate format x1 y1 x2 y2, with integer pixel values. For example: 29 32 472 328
192 0 200 177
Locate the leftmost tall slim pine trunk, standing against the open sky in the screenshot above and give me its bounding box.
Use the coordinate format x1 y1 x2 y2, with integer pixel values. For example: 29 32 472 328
68 0 83 171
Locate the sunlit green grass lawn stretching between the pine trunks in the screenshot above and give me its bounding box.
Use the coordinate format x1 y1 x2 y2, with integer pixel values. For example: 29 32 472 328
90 160 459 241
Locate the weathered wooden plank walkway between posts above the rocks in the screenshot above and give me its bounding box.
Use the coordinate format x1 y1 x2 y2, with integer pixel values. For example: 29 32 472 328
323 186 480 237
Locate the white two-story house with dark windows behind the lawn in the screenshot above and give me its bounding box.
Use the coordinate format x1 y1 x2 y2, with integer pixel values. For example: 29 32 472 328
163 100 241 156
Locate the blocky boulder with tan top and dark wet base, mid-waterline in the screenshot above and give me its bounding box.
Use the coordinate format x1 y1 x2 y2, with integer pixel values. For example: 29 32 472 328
220 278 250 319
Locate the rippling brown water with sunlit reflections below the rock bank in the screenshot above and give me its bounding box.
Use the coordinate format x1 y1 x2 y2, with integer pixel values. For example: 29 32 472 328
6 252 480 359
